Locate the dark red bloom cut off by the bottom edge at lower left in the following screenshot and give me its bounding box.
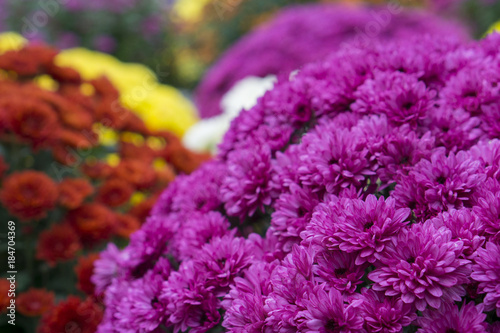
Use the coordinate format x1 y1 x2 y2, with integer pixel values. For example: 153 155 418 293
38 296 102 333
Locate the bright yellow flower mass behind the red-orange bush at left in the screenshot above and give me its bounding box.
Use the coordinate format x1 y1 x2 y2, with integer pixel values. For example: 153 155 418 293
0 33 198 137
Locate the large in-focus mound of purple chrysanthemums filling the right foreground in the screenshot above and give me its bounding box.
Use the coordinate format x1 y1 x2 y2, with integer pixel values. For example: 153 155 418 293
93 29 500 333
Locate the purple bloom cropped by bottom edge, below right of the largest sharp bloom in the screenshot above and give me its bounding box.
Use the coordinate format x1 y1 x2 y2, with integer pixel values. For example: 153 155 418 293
417 303 487 333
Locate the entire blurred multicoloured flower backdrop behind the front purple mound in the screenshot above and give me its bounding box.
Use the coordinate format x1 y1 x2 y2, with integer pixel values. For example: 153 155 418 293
0 0 500 333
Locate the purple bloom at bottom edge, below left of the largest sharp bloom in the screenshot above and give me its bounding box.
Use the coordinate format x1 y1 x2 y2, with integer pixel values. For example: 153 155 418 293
359 289 417 333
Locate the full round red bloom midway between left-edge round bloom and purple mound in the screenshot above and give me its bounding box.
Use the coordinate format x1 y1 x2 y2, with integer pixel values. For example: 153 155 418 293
66 203 115 243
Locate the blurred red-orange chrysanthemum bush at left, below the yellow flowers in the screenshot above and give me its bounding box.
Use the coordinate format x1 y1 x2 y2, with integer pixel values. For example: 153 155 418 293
0 44 210 333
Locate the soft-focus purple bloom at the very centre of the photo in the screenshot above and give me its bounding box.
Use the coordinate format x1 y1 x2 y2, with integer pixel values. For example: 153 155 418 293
221 147 272 220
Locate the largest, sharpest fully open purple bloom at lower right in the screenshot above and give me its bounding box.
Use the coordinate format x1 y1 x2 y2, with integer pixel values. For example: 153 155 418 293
368 223 471 311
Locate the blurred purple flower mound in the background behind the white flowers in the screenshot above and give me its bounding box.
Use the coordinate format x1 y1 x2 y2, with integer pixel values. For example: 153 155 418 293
195 4 467 118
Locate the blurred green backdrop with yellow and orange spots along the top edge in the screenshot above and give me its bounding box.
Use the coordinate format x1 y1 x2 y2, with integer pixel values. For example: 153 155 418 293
0 0 500 89
